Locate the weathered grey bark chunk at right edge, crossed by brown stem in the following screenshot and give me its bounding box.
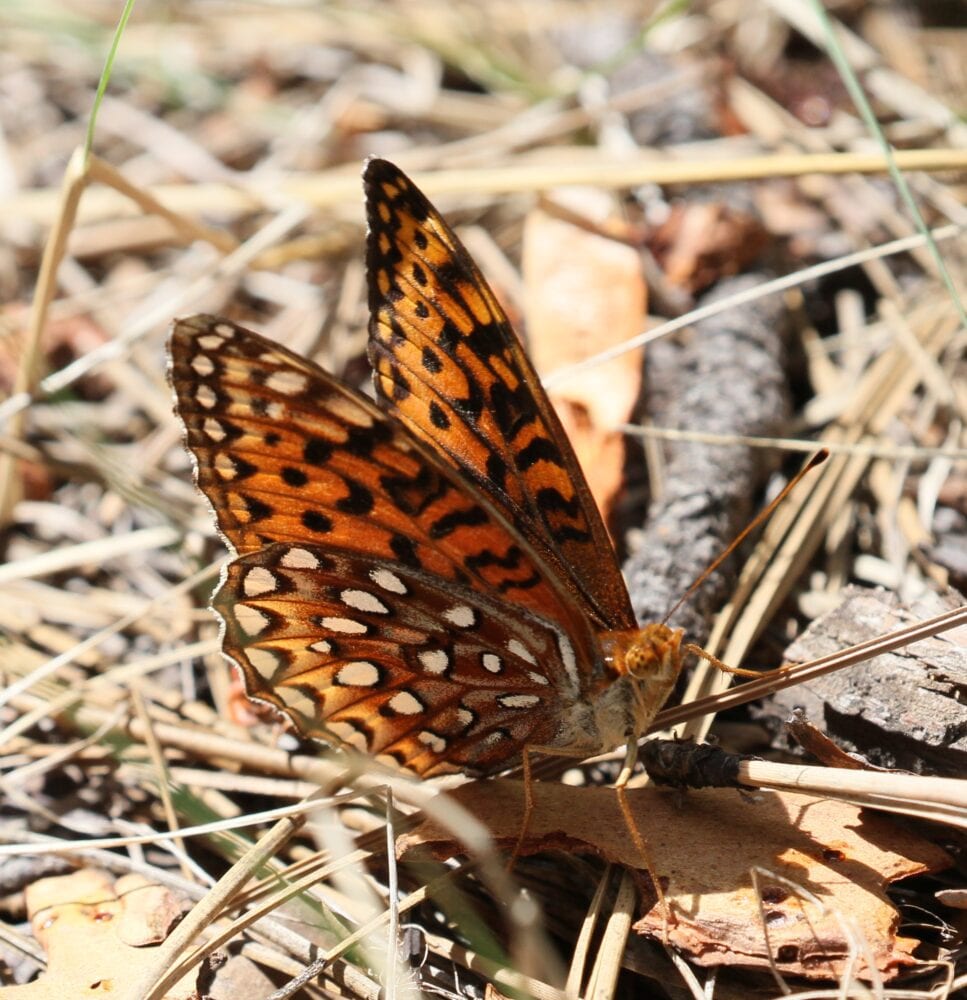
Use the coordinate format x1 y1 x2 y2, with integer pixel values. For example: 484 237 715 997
756 587 967 777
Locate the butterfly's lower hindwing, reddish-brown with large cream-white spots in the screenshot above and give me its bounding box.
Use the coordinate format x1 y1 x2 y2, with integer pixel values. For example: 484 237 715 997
214 544 581 776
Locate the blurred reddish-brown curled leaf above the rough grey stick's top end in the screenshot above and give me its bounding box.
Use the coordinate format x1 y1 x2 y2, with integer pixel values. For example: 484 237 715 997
648 202 768 294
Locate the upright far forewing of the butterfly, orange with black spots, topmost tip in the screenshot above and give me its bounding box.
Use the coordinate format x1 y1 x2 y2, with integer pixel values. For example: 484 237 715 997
364 159 635 629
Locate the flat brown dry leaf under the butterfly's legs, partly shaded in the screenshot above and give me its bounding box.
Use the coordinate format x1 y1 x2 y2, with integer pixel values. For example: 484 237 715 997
397 780 949 979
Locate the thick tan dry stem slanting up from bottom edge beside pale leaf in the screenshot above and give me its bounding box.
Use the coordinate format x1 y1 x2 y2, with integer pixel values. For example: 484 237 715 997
128 819 302 1000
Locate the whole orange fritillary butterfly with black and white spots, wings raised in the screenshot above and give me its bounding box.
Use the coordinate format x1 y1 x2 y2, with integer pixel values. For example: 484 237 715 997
170 159 682 776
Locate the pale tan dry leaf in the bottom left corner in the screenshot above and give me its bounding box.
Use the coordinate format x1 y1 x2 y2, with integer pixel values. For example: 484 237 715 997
12 868 196 1000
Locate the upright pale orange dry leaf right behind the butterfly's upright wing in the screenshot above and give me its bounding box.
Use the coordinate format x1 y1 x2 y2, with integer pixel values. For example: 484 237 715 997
523 197 646 515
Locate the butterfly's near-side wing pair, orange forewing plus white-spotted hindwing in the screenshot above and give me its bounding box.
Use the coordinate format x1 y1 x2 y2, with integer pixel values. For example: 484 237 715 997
170 316 605 775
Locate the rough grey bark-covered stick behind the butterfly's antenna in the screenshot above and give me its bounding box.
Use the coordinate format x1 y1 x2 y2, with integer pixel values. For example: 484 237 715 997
624 274 790 644
